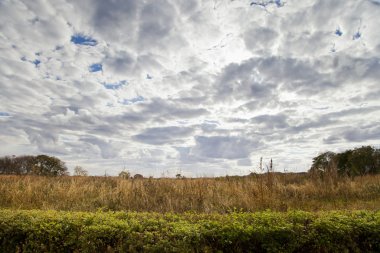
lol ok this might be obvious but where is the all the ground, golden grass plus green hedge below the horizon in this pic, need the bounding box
[0,173,380,252]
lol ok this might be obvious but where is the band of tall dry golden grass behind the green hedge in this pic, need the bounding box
[0,173,380,213]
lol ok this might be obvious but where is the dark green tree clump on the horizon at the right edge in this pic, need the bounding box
[310,146,380,176]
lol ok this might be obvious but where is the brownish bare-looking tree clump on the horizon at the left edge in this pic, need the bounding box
[0,155,67,176]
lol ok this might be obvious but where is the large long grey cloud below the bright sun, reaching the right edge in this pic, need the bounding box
[223,56,380,99]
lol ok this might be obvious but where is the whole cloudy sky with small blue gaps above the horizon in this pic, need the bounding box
[0,0,380,177]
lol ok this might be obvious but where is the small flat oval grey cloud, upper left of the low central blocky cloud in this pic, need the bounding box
[133,126,194,145]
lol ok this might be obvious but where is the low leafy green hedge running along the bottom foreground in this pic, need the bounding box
[0,210,380,252]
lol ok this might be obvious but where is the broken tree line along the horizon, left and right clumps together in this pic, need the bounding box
[0,146,380,179]
